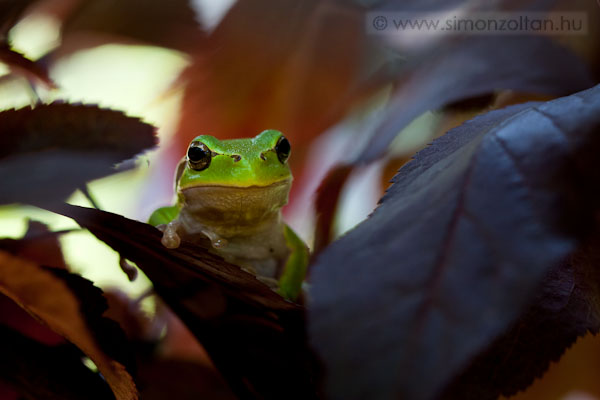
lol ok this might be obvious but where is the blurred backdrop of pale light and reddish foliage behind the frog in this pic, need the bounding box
[0,0,600,400]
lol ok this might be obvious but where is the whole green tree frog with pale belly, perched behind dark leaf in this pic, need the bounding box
[149,130,309,300]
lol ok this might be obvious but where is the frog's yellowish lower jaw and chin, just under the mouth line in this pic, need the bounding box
[180,179,291,227]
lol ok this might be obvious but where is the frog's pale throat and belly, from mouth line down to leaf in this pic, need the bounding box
[178,183,290,279]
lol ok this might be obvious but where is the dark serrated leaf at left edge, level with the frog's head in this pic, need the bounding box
[0,103,156,204]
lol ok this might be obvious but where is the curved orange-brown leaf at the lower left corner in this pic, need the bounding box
[0,251,137,400]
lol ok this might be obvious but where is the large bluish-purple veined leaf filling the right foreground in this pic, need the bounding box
[309,86,600,400]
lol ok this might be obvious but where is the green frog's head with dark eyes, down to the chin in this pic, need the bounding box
[176,130,292,228]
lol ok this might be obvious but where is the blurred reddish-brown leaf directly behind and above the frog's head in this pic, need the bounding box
[174,0,384,181]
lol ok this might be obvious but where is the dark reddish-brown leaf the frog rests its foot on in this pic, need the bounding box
[51,205,316,399]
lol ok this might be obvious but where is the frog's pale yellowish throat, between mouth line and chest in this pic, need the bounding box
[179,179,291,238]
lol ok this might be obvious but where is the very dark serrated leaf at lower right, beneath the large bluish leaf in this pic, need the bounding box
[443,236,600,400]
